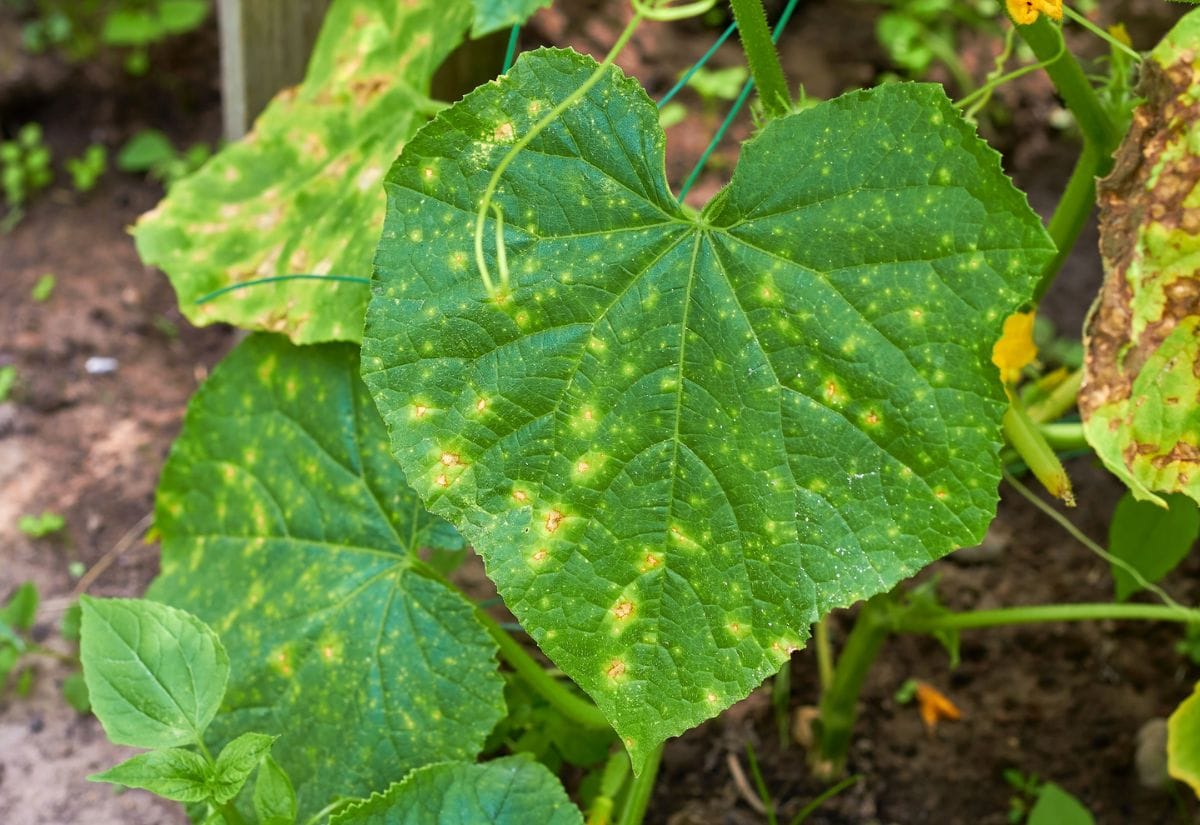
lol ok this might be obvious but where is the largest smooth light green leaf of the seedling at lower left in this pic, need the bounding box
[79,596,229,748]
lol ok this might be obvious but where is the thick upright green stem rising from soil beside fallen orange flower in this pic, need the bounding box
[816,595,888,775]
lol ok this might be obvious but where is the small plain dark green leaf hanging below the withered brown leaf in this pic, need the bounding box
[1109,492,1200,602]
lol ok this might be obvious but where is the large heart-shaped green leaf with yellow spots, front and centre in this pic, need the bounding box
[362,50,1052,770]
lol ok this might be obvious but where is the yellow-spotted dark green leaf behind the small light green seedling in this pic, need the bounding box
[150,335,504,819]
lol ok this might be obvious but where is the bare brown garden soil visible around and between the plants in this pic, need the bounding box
[0,0,1200,825]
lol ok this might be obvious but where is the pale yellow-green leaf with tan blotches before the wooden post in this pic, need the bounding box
[134,0,473,343]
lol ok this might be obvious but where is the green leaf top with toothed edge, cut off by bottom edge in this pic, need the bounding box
[330,755,583,825]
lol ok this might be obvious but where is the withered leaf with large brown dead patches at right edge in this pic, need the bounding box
[1079,11,1200,506]
